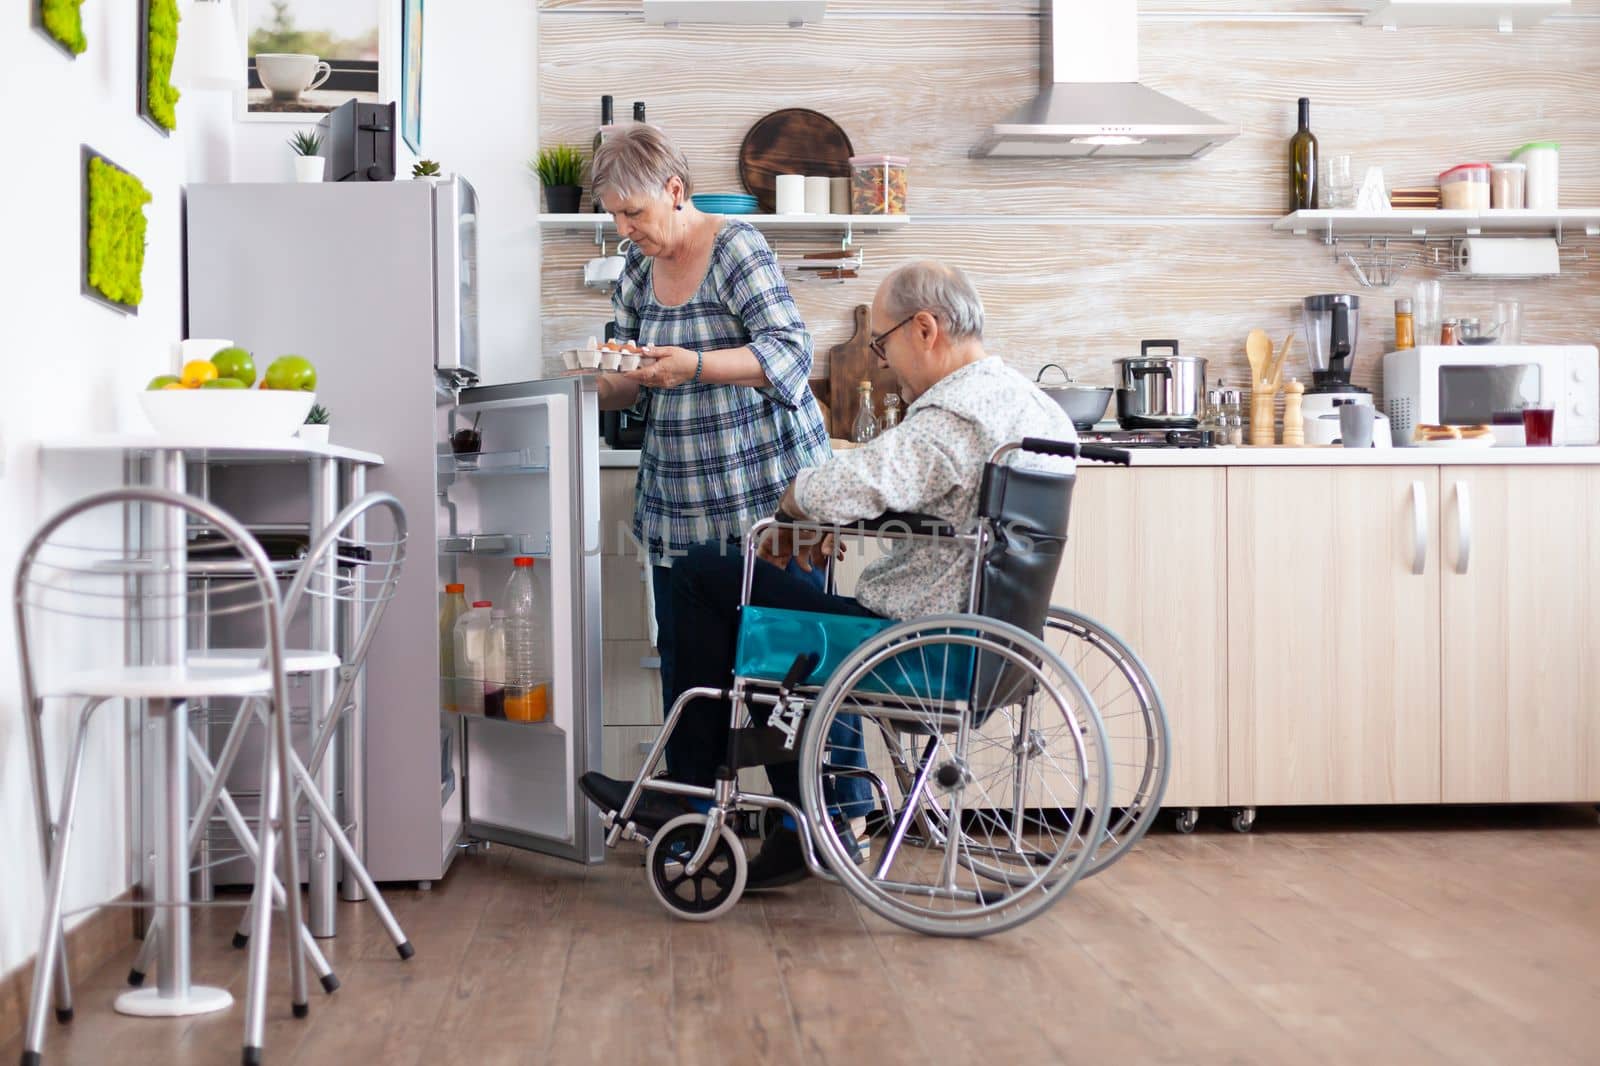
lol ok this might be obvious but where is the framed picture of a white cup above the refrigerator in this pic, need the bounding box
[238,0,389,125]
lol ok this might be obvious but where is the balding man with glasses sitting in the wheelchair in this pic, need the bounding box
[582,261,1077,892]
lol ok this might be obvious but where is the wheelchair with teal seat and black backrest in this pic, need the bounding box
[602,439,1168,936]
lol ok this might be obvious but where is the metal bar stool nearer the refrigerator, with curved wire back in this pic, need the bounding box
[128,493,414,1036]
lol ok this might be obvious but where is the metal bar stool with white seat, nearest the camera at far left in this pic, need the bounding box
[14,488,309,1066]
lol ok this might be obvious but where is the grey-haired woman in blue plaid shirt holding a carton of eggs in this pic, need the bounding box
[590,123,830,784]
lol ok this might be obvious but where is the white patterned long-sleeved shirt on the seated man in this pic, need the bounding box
[795,355,1078,619]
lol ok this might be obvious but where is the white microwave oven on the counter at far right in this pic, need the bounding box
[1384,344,1600,445]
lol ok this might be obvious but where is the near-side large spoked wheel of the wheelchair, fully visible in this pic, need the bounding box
[800,615,1110,936]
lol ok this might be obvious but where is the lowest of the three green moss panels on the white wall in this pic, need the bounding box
[83,144,150,314]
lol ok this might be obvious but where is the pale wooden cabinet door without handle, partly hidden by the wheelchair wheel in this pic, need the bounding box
[1053,466,1227,807]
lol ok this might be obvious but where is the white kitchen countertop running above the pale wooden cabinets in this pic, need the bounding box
[600,447,1600,467]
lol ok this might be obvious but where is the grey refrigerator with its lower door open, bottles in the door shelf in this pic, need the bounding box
[184,178,603,882]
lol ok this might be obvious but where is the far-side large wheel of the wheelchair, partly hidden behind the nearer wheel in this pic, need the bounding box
[1045,607,1170,877]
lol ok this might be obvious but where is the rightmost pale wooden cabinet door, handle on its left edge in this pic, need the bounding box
[1440,466,1600,804]
